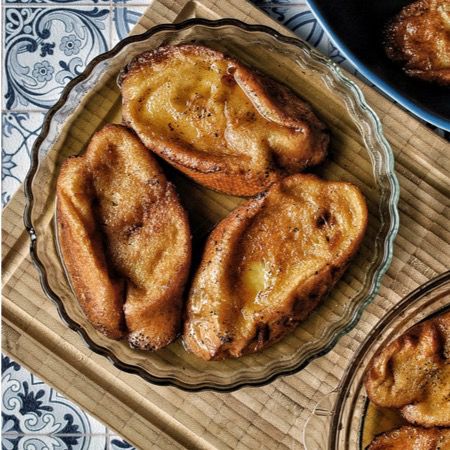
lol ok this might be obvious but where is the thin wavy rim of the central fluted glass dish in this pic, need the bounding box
[23,18,399,392]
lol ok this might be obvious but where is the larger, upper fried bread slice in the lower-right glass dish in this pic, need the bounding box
[365,312,450,426]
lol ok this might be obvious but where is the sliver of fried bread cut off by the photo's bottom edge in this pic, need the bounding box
[367,426,450,450]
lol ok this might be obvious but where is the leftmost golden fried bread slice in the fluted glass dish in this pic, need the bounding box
[57,125,191,350]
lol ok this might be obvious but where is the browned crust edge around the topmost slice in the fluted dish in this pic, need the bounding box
[118,44,330,196]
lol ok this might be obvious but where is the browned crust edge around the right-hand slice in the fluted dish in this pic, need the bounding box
[183,174,368,360]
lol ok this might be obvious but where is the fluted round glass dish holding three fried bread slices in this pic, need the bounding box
[25,19,399,391]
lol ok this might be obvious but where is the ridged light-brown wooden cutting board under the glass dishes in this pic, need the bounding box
[2,0,450,450]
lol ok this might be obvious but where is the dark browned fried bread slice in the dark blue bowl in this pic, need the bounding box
[385,0,450,86]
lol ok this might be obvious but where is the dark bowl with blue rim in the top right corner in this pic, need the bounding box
[307,0,450,131]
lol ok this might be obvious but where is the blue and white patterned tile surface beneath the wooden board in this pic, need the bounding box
[1,0,446,450]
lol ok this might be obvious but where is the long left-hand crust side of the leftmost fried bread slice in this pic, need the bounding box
[57,159,126,339]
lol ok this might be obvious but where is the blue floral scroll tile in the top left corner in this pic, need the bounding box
[3,7,110,110]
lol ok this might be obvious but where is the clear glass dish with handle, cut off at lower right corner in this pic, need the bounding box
[303,271,450,450]
